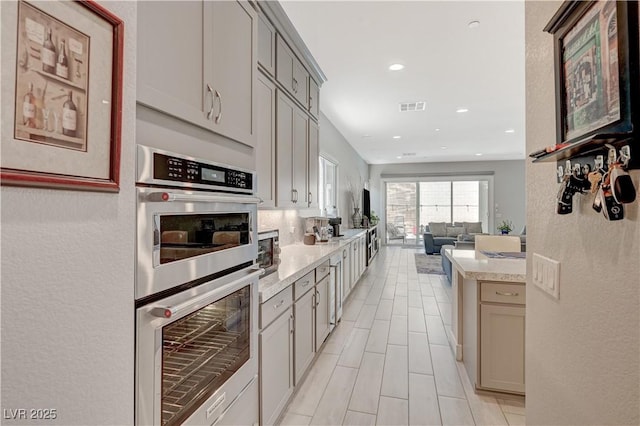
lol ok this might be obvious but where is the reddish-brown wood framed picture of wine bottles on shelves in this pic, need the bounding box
[0,0,124,192]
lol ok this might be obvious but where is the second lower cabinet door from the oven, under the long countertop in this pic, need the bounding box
[293,290,315,385]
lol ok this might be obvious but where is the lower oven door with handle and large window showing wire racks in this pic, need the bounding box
[136,268,263,426]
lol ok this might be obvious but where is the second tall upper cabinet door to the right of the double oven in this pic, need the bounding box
[276,89,295,207]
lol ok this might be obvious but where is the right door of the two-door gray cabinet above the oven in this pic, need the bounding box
[205,1,258,146]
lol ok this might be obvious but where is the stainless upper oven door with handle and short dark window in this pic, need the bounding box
[135,188,259,299]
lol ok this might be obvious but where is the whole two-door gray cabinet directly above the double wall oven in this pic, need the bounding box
[137,1,258,146]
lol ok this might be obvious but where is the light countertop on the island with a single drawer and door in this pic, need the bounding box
[445,249,527,282]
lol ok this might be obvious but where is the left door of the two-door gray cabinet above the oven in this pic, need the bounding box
[136,1,209,127]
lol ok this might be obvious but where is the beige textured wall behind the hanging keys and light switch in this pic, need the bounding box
[525,1,640,425]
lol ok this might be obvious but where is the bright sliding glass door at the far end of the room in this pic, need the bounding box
[386,177,492,245]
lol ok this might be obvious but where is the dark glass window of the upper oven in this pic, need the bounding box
[159,212,250,264]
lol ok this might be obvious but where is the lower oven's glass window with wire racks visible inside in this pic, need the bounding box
[162,286,251,425]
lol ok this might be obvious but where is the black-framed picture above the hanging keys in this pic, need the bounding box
[544,0,639,146]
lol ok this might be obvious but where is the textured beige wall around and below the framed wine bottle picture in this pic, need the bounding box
[0,2,137,425]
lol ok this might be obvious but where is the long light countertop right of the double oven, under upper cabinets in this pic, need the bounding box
[258,229,367,303]
